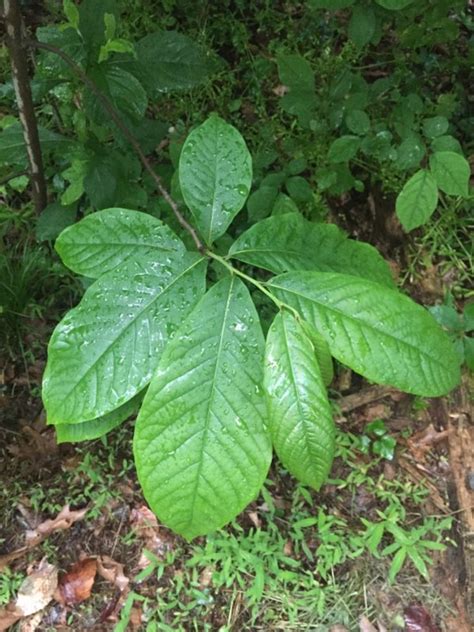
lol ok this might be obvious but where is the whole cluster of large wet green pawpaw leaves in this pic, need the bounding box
[43,116,460,539]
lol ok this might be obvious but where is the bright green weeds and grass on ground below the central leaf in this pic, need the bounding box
[111,434,452,631]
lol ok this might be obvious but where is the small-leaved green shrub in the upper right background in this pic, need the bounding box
[272,0,470,232]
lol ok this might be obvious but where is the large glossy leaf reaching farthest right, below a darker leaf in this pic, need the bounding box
[269,272,460,397]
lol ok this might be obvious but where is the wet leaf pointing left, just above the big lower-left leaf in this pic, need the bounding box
[55,208,185,278]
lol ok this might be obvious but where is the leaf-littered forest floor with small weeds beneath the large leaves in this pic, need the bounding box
[0,204,474,632]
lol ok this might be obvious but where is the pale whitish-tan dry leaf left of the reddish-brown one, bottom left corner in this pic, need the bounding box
[15,559,58,617]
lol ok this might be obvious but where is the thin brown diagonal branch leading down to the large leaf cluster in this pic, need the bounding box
[26,40,205,253]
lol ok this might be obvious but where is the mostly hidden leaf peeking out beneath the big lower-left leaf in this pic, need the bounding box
[56,393,143,443]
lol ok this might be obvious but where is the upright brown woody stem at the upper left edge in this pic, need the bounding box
[3,0,47,214]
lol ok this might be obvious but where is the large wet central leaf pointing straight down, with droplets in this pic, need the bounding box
[134,277,271,539]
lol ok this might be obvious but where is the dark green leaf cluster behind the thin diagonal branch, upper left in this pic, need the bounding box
[0,0,216,227]
